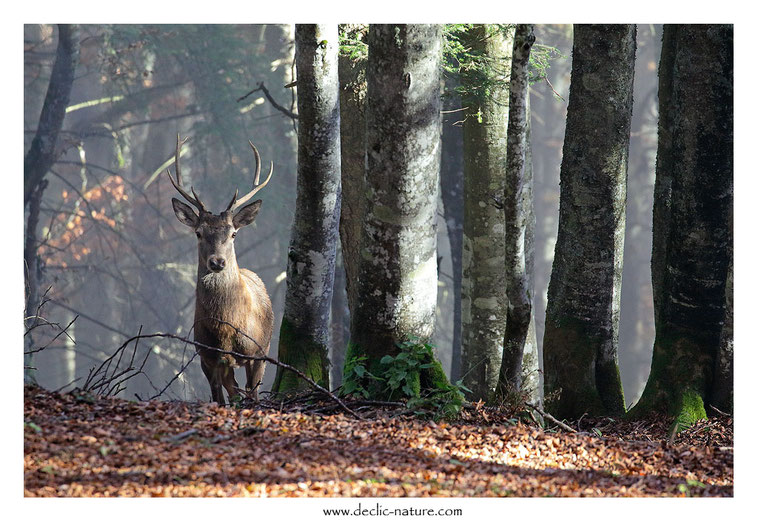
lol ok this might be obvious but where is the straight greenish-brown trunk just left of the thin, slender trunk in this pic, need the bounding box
[461,24,513,400]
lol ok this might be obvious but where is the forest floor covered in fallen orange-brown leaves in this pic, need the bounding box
[24,386,734,497]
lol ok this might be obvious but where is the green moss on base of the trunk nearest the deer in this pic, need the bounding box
[271,318,329,393]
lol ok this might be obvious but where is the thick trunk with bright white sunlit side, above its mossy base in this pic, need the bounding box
[346,24,444,394]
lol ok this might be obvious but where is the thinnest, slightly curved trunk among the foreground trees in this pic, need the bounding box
[498,24,534,398]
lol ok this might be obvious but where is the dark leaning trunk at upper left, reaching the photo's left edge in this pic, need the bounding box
[24,24,79,206]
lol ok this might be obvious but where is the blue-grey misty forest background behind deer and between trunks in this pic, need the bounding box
[24,25,661,404]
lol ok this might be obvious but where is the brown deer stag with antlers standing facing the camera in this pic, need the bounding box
[167,136,274,406]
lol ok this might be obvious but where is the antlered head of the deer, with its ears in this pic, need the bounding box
[166,135,274,273]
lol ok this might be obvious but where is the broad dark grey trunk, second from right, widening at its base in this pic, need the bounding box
[543,25,636,418]
